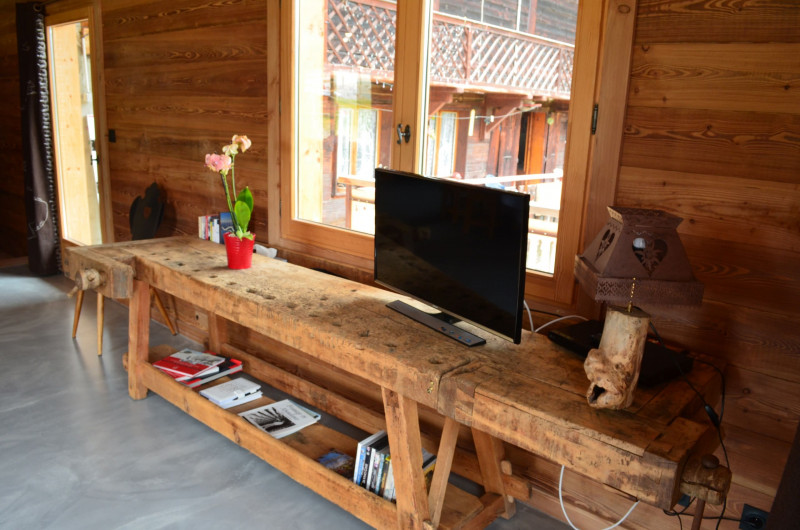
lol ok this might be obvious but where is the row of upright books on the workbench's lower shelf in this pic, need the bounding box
[353,431,436,501]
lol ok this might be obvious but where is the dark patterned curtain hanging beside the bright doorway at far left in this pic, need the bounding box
[17,2,61,275]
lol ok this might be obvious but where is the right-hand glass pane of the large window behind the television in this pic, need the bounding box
[424,0,578,273]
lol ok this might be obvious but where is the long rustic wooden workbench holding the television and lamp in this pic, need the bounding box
[65,238,730,528]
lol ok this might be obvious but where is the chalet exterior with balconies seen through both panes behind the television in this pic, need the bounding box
[294,0,577,273]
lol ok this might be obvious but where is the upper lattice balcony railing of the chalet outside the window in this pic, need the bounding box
[327,0,574,99]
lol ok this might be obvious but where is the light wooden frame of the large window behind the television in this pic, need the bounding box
[267,0,636,307]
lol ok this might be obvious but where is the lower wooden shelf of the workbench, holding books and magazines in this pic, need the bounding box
[134,346,503,529]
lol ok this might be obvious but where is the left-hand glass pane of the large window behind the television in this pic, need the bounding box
[293,0,396,233]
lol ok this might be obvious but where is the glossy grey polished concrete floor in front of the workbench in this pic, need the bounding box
[0,265,568,530]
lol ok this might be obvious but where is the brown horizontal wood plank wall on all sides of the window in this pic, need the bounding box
[0,0,800,530]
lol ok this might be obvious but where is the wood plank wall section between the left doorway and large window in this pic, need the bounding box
[103,0,267,239]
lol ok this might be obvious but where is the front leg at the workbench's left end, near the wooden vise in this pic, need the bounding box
[128,280,150,399]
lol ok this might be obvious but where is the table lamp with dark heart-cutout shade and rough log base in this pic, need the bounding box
[575,206,703,409]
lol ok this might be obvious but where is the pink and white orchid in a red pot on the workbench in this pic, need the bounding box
[206,134,255,269]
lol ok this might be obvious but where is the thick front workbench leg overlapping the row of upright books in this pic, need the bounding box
[381,388,432,530]
